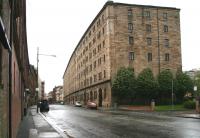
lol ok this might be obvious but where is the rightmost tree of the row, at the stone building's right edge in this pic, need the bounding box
[175,71,193,101]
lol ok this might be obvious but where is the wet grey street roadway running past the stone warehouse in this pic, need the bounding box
[43,105,200,138]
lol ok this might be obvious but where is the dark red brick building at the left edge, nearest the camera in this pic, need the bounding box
[0,0,29,138]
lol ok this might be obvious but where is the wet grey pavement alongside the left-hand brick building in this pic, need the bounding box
[17,106,68,138]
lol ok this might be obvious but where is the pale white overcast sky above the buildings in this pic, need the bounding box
[27,0,200,93]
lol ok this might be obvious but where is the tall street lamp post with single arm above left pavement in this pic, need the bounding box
[36,47,56,113]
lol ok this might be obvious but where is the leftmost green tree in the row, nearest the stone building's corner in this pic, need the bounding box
[112,67,136,103]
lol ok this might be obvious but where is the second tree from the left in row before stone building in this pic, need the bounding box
[137,68,158,102]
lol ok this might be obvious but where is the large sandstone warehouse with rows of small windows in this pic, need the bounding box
[63,1,182,107]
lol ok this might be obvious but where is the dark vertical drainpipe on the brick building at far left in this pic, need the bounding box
[9,0,14,138]
